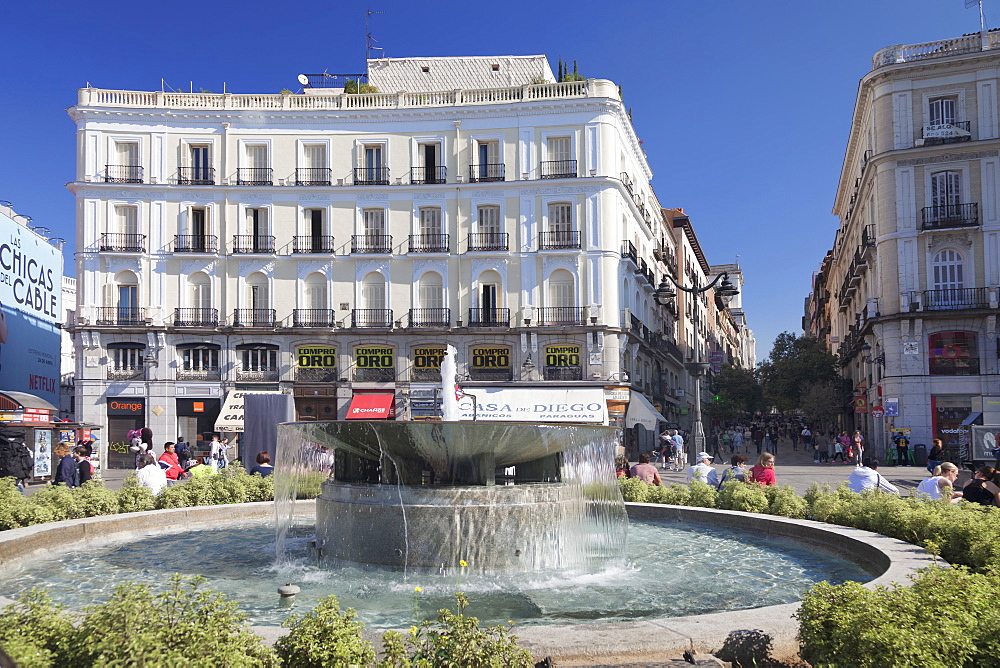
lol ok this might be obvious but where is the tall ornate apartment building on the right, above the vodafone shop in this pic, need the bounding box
[804,32,1000,461]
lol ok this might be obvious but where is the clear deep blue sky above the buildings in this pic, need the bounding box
[0,0,1000,358]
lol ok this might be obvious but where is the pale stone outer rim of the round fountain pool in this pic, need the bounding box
[0,500,943,665]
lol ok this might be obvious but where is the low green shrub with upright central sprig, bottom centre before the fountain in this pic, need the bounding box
[382,592,534,668]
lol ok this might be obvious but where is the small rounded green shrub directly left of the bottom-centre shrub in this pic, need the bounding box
[274,596,375,668]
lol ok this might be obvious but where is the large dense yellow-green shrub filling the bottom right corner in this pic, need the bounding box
[796,568,1000,668]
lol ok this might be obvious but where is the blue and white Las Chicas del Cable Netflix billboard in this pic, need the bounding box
[0,212,63,406]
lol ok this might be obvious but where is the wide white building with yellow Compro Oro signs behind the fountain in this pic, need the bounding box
[69,56,744,466]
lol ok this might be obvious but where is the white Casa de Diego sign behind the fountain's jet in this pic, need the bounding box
[458,386,608,424]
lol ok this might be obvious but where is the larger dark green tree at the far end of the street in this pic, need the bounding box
[758,332,849,419]
